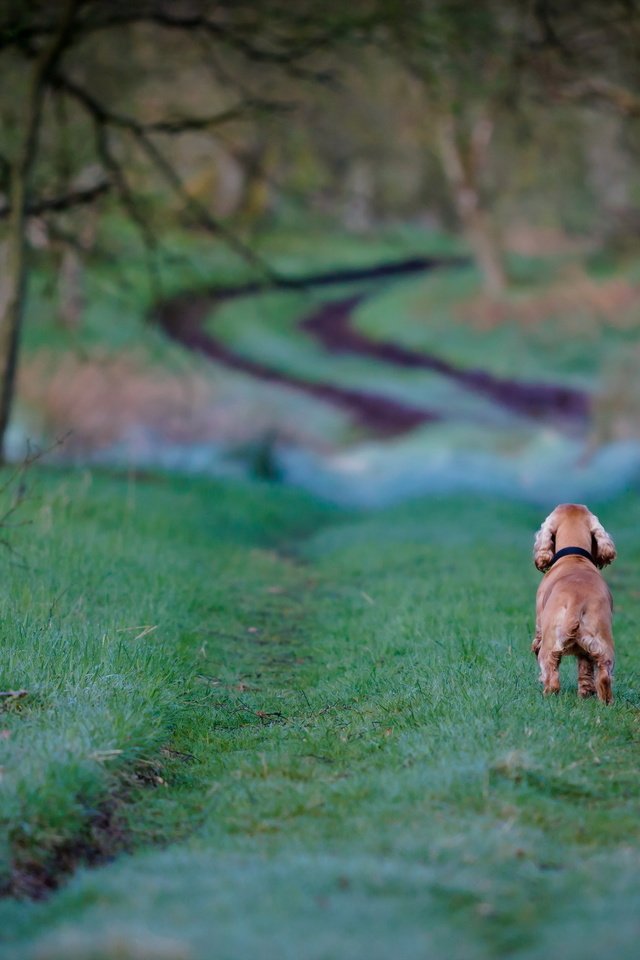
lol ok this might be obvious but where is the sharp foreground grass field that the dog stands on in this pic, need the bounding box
[0,471,640,960]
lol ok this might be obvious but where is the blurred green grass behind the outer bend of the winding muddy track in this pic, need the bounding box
[24,214,460,362]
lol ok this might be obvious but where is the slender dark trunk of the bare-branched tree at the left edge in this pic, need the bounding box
[0,0,79,462]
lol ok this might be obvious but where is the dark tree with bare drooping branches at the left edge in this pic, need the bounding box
[0,0,350,456]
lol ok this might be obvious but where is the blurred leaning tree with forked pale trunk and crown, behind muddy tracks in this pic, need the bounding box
[362,0,514,296]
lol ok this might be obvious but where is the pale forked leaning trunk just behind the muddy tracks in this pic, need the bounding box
[439,114,507,297]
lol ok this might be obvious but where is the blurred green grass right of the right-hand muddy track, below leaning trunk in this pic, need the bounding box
[356,258,638,388]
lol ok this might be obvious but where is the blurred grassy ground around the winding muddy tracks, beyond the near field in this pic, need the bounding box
[16,219,640,505]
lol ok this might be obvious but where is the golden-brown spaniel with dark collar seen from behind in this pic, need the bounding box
[531,503,616,703]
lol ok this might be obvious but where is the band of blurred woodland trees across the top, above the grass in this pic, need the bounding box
[0,0,640,464]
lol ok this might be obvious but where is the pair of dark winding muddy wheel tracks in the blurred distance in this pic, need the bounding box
[153,257,589,435]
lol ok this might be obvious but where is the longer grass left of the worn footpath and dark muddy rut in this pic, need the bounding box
[0,473,330,883]
